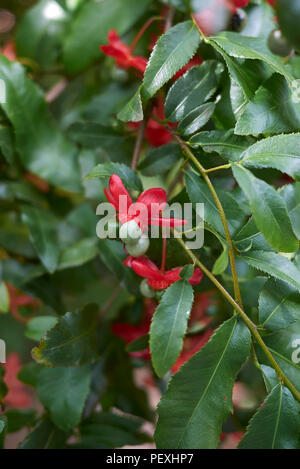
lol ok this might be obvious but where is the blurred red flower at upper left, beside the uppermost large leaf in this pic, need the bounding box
[100,29,147,73]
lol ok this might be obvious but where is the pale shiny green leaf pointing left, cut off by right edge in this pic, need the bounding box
[241,133,300,180]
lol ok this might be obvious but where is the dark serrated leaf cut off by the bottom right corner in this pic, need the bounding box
[238,384,300,449]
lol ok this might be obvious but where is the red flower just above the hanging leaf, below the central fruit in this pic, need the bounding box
[124,256,203,290]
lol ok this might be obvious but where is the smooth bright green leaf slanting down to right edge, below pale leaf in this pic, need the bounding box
[232,165,299,252]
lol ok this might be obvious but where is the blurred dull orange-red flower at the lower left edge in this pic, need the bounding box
[3,353,31,409]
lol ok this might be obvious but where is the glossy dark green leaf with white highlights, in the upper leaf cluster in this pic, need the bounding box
[165,60,223,122]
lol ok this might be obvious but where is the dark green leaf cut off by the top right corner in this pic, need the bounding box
[276,0,300,50]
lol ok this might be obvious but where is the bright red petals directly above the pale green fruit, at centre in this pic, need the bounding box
[104,174,186,230]
